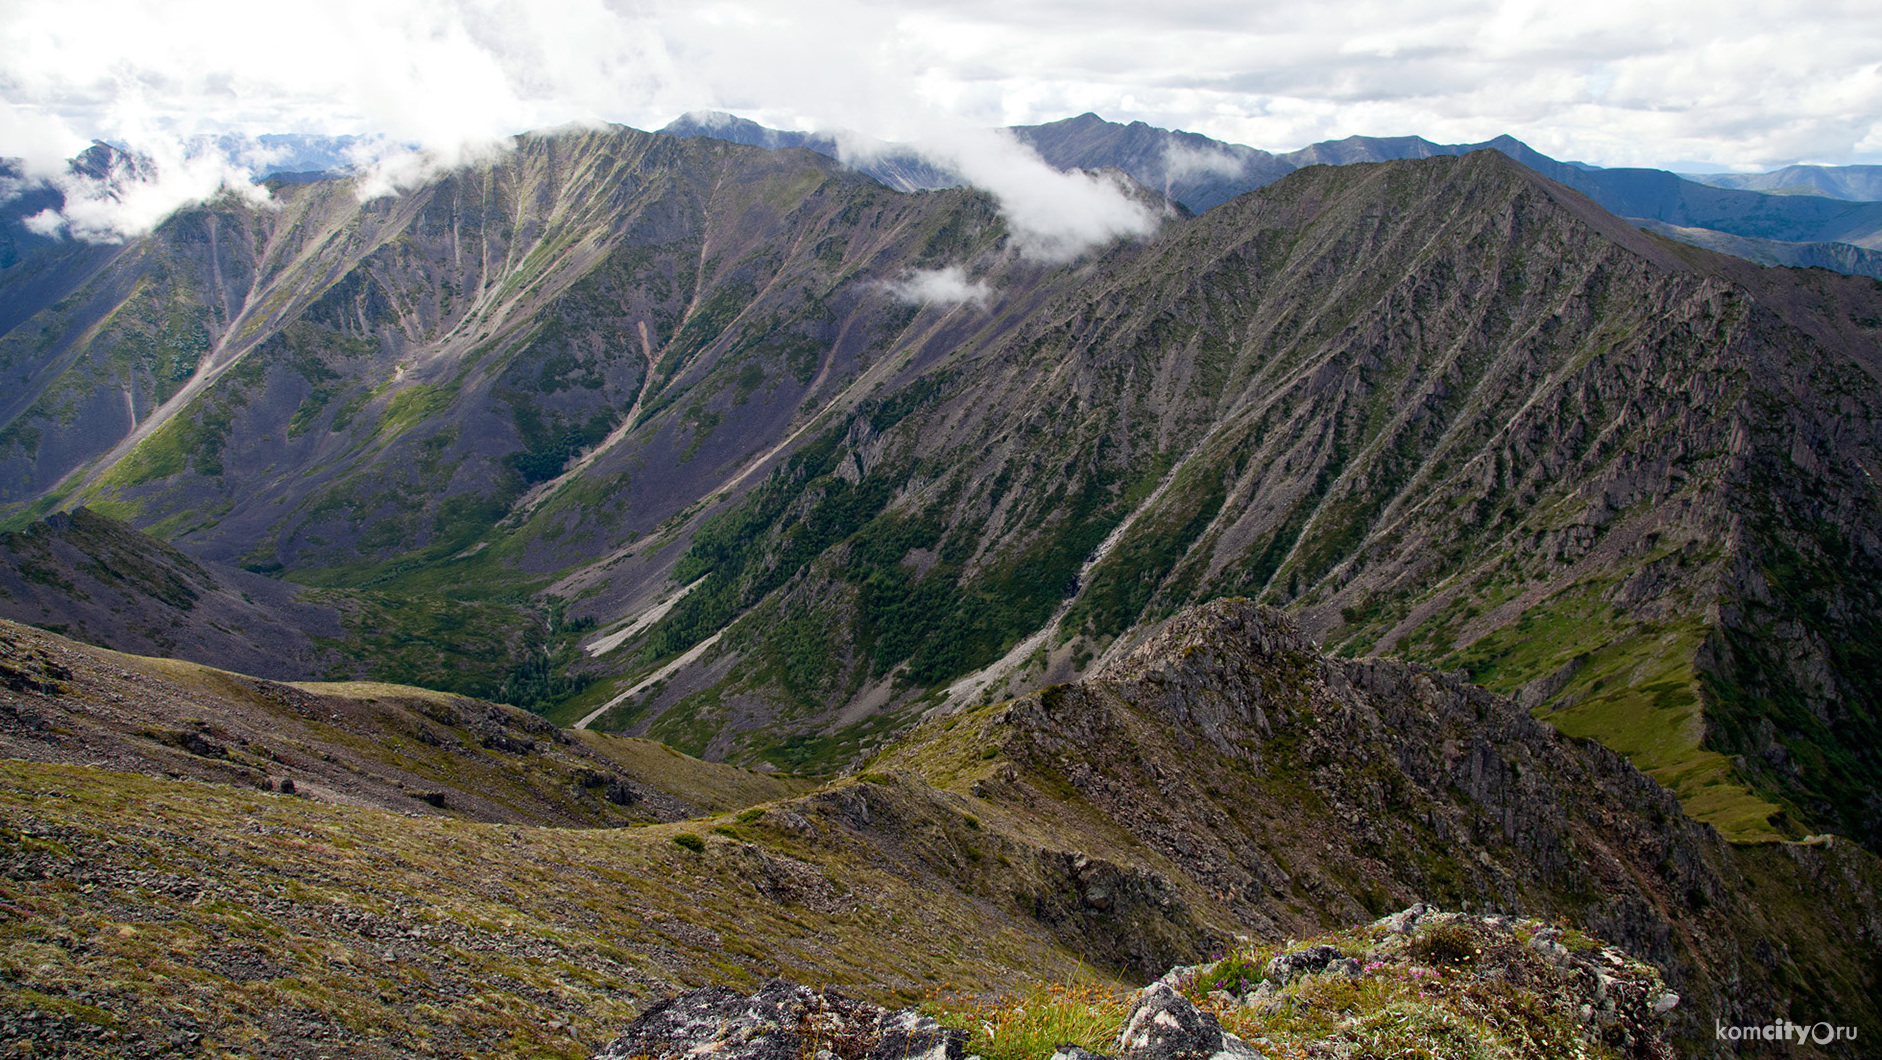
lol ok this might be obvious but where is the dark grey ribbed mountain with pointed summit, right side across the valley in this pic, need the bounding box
[583,153,1882,836]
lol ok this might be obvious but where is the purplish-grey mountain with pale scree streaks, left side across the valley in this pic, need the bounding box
[8,130,1016,567]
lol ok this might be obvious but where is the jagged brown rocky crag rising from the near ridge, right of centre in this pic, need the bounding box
[886,601,1882,1047]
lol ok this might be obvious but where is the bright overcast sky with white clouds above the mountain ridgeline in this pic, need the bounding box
[0,0,1882,239]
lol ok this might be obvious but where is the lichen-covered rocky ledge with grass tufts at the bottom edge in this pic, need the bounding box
[595,906,1679,1060]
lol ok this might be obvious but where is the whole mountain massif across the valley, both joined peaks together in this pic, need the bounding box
[0,130,1882,843]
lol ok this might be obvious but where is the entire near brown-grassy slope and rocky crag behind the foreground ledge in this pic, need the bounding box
[0,601,1882,1056]
